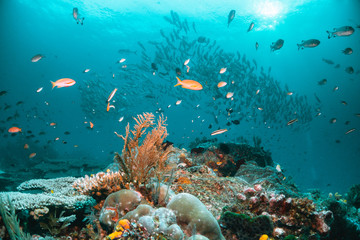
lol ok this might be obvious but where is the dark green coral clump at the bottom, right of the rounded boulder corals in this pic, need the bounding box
[220,211,274,240]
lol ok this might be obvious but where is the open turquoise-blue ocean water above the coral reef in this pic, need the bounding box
[0,0,360,195]
